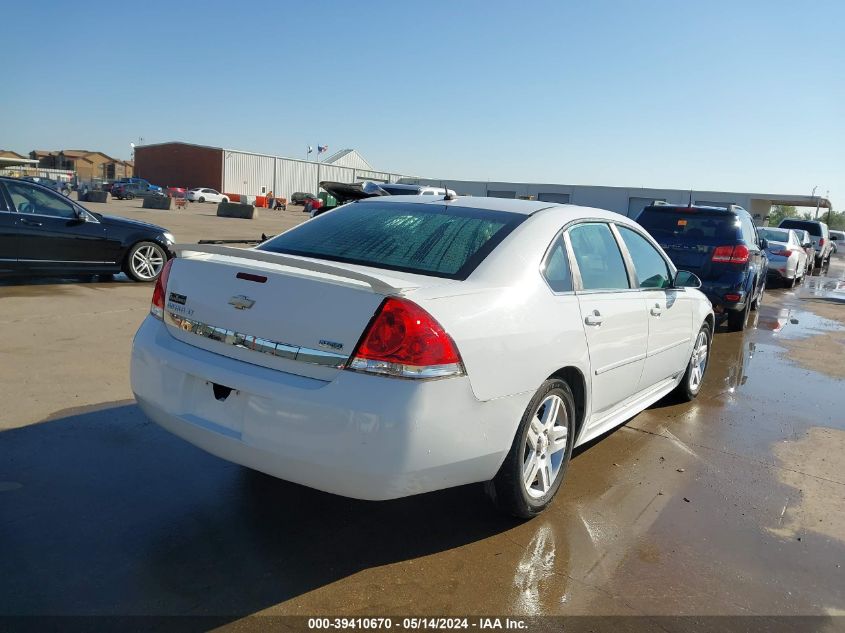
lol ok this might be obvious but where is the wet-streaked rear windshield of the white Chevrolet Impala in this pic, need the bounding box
[258,202,527,279]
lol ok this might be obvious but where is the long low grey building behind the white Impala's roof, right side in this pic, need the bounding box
[400,178,831,224]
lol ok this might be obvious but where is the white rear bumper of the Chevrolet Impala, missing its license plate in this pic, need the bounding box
[131,317,532,500]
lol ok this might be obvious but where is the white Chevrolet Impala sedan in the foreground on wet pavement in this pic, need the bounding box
[131,196,714,517]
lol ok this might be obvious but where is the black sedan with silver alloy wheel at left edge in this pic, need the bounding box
[0,177,173,281]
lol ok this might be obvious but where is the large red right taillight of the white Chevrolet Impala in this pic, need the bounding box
[346,297,464,378]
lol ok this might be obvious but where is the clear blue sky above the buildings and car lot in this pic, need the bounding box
[0,0,845,208]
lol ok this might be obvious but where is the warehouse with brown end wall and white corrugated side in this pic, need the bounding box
[135,142,401,198]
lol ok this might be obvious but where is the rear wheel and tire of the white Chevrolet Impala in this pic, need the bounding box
[492,379,576,519]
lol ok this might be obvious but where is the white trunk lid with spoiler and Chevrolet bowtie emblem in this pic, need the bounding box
[164,246,454,381]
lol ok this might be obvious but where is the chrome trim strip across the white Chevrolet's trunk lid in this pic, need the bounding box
[164,310,349,369]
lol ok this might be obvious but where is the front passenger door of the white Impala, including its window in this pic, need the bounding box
[616,225,693,391]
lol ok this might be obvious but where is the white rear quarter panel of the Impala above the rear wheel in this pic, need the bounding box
[410,207,592,402]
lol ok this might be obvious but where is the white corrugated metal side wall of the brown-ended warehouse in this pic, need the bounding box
[223,150,402,198]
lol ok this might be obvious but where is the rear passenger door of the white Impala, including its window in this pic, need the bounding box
[567,222,648,424]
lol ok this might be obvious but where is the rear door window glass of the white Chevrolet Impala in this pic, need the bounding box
[569,224,630,290]
